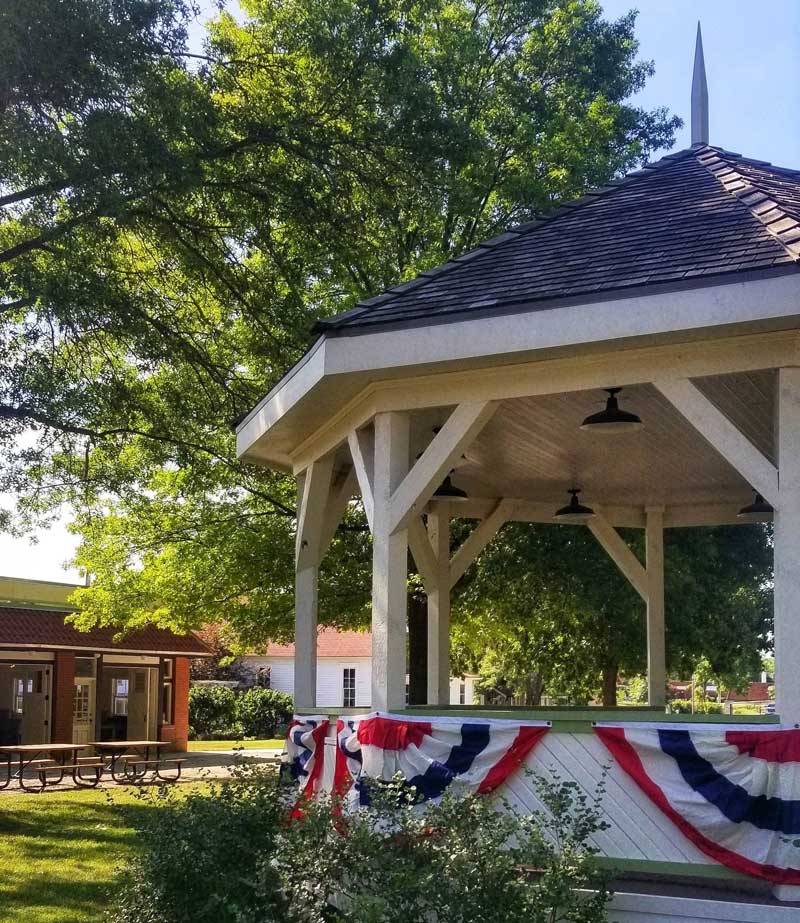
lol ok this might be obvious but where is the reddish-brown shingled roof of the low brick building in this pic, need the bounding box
[0,606,211,657]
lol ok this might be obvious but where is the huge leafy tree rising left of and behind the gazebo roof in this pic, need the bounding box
[6,0,764,700]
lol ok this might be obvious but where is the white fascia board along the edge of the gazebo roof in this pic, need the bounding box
[236,273,800,462]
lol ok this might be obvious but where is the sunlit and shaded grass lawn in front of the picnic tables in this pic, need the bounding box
[0,788,200,923]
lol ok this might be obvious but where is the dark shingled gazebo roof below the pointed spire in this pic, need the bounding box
[319,144,800,335]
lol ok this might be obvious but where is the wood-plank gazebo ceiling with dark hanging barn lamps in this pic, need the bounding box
[404,370,776,509]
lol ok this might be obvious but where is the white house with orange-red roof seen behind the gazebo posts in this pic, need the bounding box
[240,628,478,710]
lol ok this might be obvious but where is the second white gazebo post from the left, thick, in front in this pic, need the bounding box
[372,412,409,711]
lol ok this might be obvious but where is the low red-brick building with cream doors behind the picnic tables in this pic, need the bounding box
[0,577,209,750]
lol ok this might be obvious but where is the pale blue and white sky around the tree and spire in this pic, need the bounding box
[0,0,800,582]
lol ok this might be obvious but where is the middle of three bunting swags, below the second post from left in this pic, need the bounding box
[334,712,549,804]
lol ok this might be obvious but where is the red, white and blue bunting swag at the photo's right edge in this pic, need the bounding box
[595,725,800,885]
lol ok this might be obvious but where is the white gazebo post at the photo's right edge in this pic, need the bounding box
[774,368,800,724]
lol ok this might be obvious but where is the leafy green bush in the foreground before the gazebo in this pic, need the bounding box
[109,768,609,923]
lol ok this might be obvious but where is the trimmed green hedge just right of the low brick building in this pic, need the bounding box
[189,686,293,740]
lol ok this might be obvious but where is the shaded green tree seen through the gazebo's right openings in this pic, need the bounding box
[455,524,772,705]
